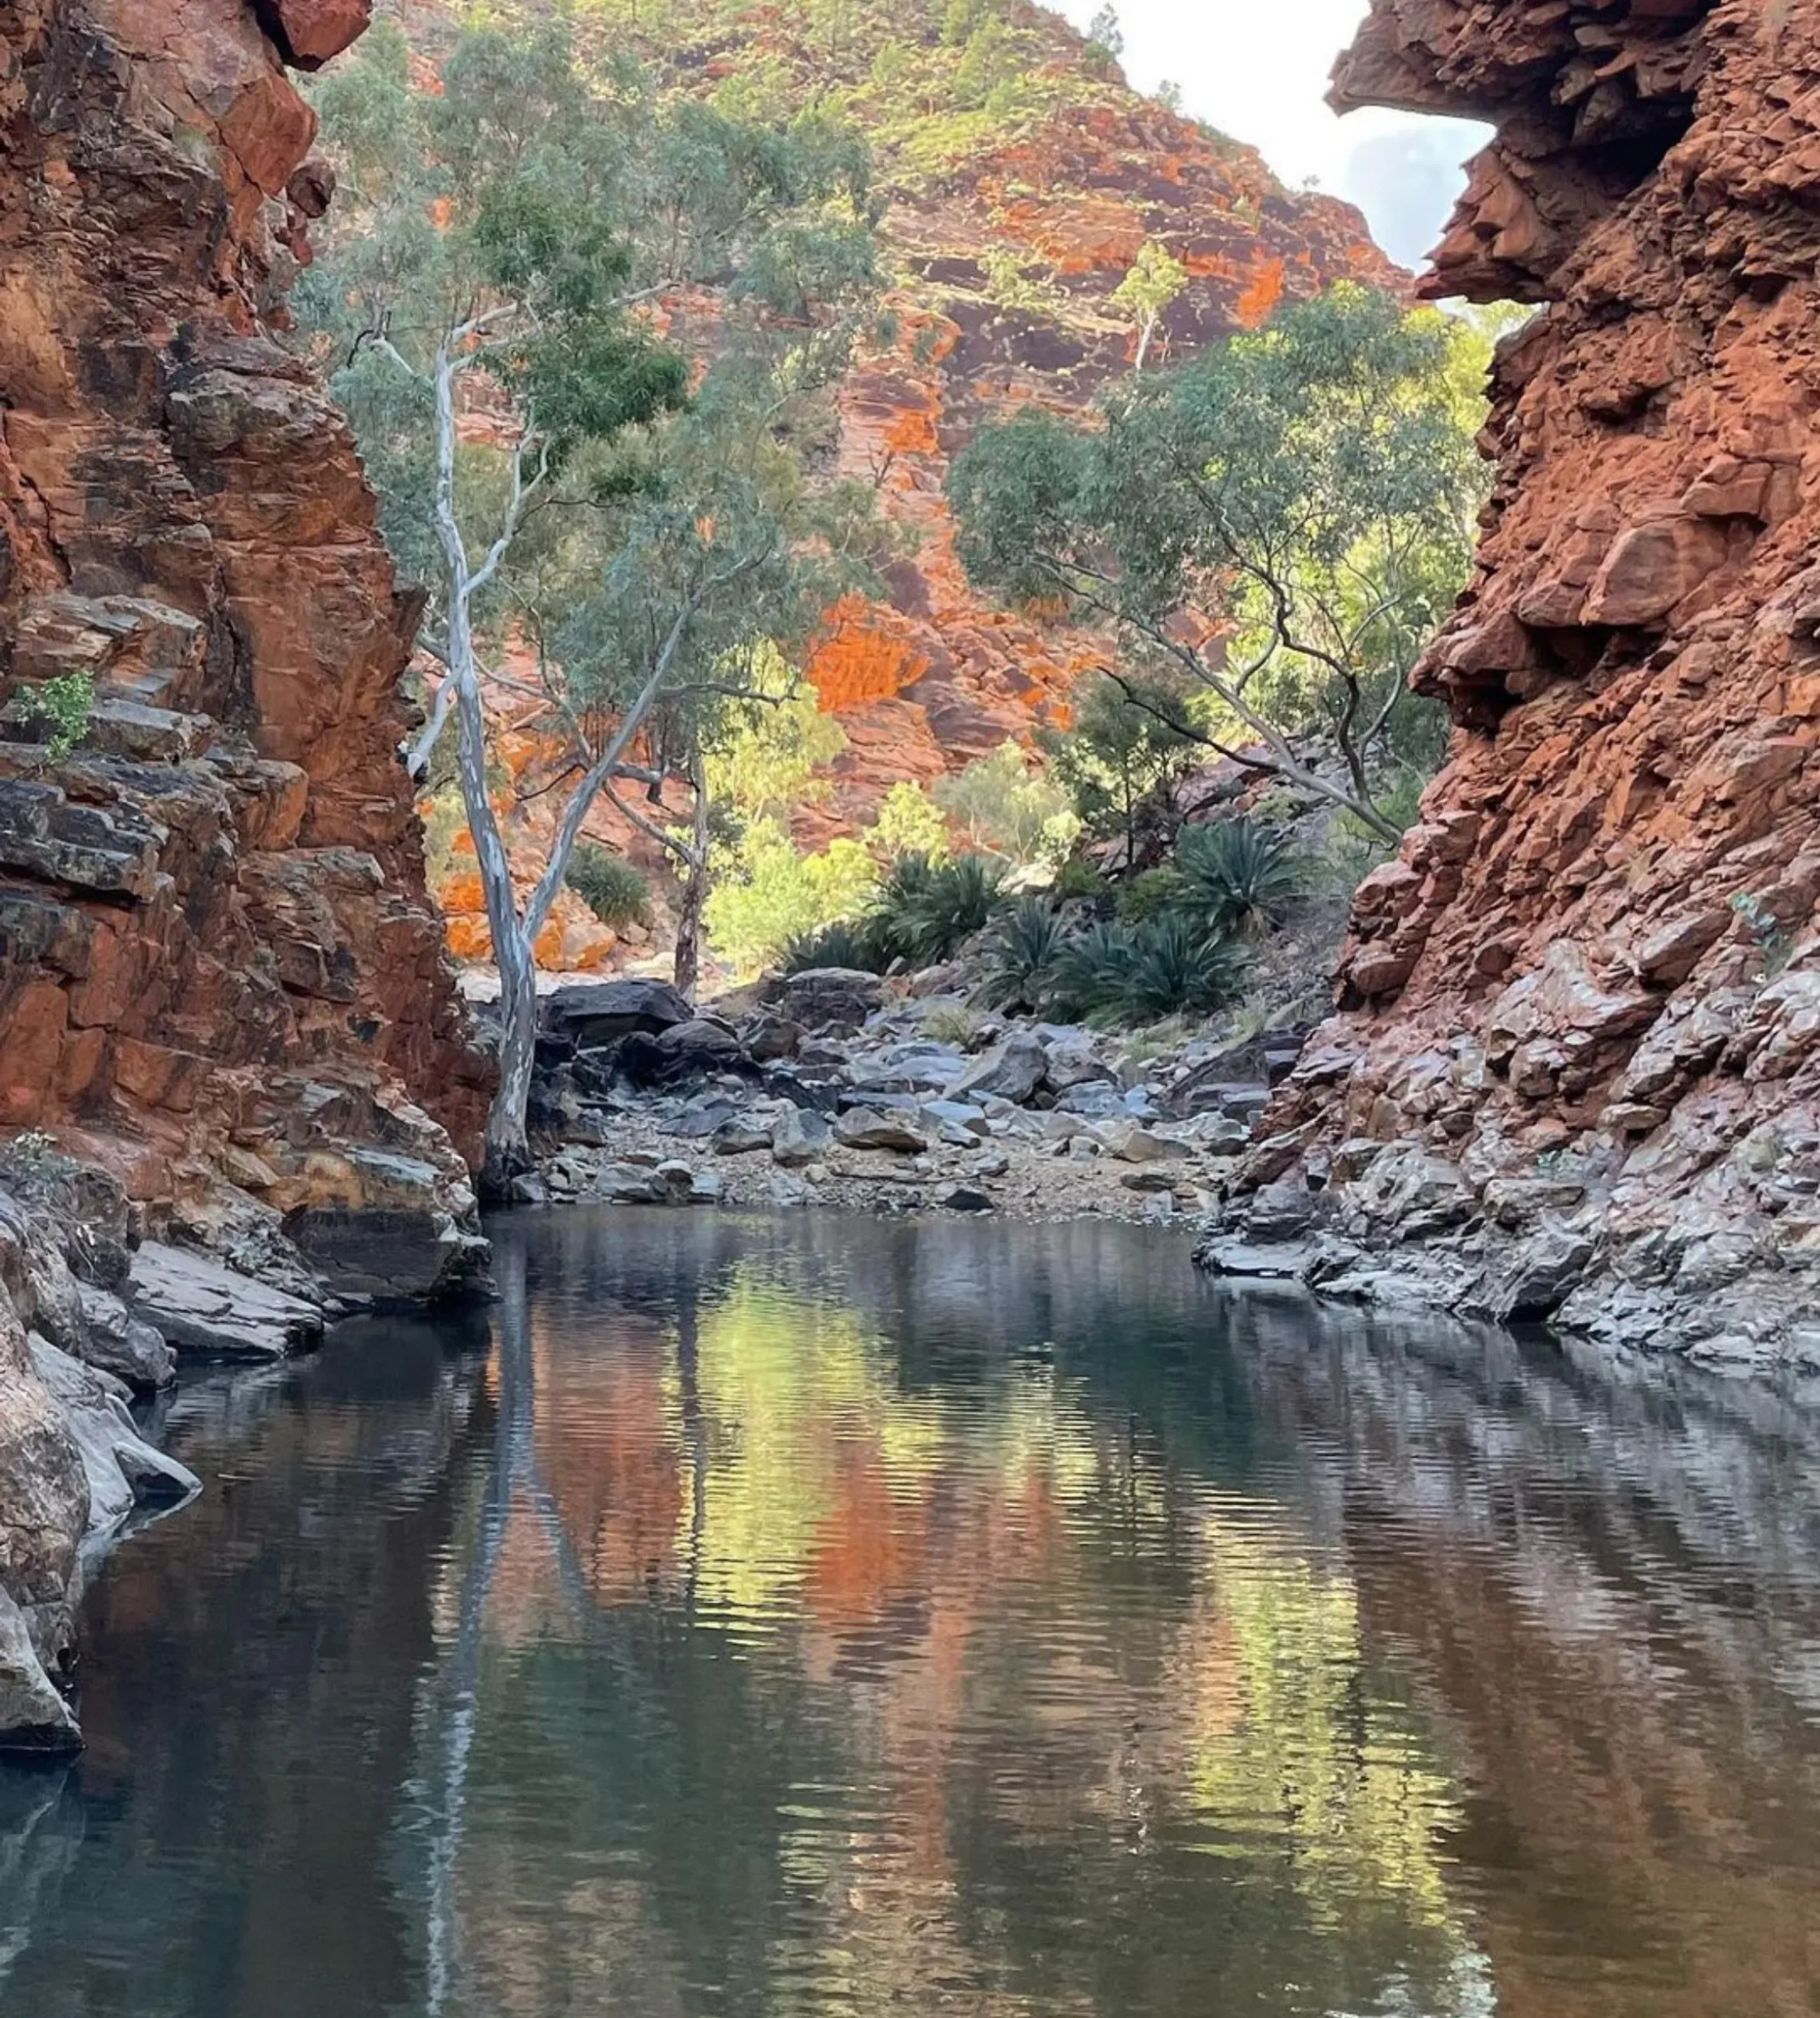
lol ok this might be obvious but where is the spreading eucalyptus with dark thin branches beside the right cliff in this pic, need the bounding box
[951,285,1485,842]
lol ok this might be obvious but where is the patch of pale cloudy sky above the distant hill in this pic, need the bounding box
[1049,0,1489,266]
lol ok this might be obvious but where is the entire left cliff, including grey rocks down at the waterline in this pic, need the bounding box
[0,0,486,1748]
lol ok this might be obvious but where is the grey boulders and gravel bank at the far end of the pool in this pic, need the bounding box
[498,969,1300,1219]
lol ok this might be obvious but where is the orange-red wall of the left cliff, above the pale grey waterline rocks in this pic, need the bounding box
[0,0,486,1251]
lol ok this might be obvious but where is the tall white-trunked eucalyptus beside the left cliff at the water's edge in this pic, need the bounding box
[300,22,876,1185]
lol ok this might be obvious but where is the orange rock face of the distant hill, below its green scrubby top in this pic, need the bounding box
[810,95,1402,819]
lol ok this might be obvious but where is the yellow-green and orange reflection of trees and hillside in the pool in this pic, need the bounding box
[405,1211,1479,2014]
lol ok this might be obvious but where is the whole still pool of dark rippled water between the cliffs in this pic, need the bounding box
[0,1211,1820,2018]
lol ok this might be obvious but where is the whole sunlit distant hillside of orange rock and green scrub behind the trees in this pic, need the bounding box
[348,0,1401,965]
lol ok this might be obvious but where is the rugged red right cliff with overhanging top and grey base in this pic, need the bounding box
[1208,0,1820,1366]
